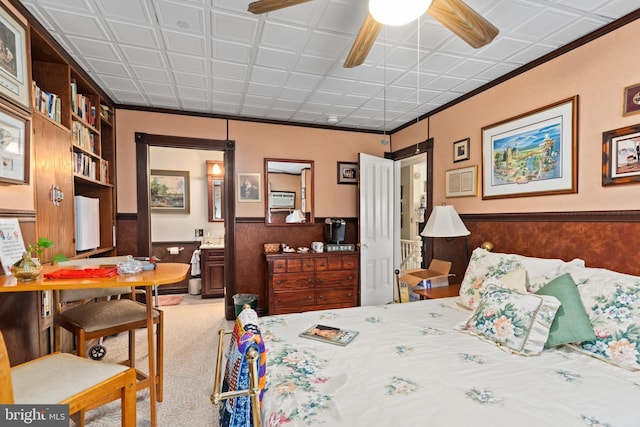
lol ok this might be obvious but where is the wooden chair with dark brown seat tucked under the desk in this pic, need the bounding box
[54,257,164,402]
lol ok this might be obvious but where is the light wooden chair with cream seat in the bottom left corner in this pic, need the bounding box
[0,332,136,427]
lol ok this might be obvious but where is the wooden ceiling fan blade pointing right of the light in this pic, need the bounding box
[427,0,500,49]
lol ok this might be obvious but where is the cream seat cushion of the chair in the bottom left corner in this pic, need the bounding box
[11,353,129,404]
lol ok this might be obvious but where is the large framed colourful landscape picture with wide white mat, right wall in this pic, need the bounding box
[482,95,578,199]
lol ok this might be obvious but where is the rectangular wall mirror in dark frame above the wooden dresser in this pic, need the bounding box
[264,159,314,226]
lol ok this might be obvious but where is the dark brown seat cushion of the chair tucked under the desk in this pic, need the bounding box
[58,298,159,332]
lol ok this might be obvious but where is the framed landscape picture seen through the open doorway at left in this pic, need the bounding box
[149,169,189,214]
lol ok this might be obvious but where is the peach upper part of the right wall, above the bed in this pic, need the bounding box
[392,21,640,213]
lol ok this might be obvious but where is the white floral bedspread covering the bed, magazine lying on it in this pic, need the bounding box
[260,299,640,427]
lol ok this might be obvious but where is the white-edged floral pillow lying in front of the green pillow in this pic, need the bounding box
[456,285,560,355]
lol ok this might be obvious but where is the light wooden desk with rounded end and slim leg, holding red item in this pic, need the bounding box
[0,263,190,427]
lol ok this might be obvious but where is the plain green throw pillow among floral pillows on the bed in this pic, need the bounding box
[536,273,596,348]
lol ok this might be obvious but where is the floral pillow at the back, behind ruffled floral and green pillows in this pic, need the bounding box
[458,248,584,309]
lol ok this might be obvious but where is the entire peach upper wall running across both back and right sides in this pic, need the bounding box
[112,21,640,217]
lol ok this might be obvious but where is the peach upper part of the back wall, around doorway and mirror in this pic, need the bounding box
[116,110,388,217]
